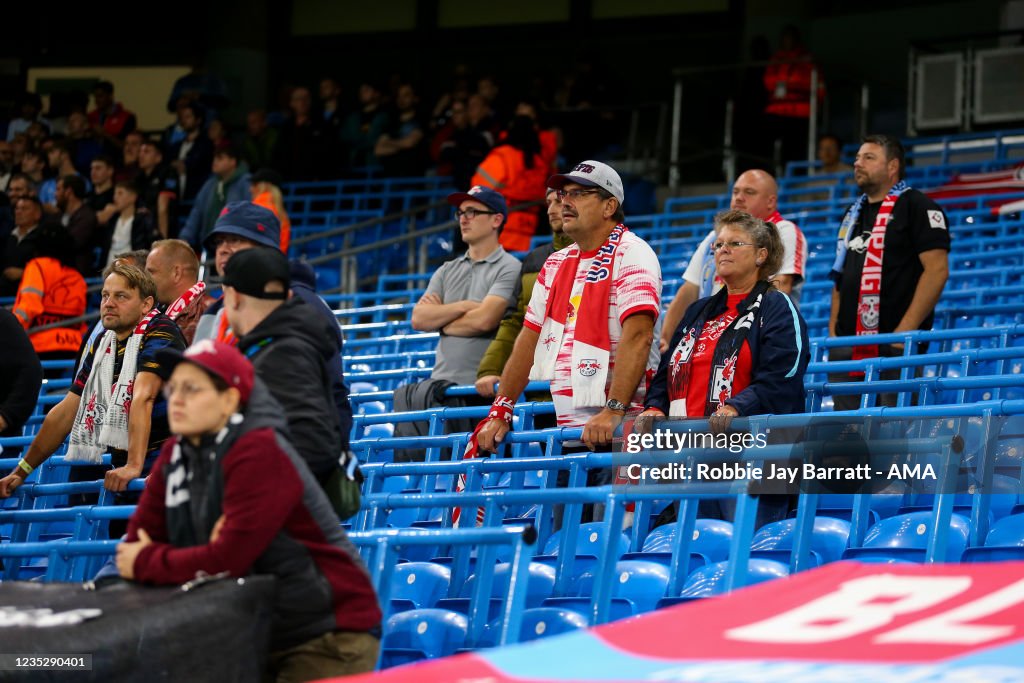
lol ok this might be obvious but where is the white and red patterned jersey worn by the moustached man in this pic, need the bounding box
[523,232,662,427]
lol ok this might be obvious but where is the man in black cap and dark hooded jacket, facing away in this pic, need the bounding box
[223,249,342,485]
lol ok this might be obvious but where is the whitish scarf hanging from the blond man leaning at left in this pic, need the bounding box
[66,308,160,463]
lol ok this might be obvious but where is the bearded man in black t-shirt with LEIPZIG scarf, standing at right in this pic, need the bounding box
[828,135,950,410]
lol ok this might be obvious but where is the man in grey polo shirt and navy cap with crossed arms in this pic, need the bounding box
[413,186,521,384]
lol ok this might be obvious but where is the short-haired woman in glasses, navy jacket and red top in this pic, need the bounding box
[642,211,810,426]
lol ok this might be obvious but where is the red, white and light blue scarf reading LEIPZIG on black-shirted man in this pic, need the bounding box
[829,180,910,360]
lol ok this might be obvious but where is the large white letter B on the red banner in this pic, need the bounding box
[725,574,971,643]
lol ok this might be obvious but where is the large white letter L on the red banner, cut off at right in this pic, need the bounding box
[876,581,1024,645]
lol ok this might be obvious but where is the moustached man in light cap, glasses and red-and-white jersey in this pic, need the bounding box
[476,161,662,458]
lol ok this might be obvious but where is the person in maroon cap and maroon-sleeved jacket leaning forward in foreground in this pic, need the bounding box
[116,341,382,681]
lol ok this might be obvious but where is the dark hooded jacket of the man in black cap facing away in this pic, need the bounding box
[239,298,342,481]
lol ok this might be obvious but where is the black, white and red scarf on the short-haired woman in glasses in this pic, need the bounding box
[669,280,771,417]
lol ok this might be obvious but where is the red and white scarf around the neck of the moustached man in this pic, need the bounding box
[529,223,629,408]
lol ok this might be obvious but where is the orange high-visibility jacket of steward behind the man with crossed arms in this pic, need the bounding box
[471,144,551,251]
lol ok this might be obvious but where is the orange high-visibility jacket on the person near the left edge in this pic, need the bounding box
[13,256,86,353]
